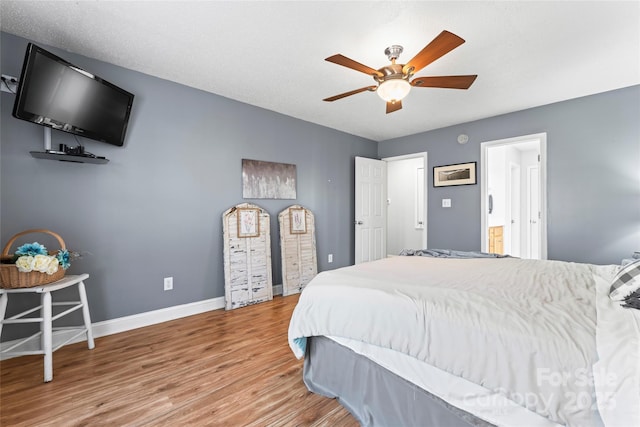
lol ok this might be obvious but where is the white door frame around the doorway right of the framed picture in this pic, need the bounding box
[480,132,547,259]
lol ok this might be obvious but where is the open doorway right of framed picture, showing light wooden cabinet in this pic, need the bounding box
[481,133,547,259]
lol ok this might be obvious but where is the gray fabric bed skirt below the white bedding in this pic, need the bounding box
[303,337,492,427]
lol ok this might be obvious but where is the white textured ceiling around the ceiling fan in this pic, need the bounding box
[0,0,640,141]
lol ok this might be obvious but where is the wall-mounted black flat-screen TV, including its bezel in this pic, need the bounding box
[13,43,133,146]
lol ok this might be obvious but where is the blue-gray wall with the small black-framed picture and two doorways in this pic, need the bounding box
[378,86,640,264]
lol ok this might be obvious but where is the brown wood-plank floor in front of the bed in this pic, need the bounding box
[0,296,358,427]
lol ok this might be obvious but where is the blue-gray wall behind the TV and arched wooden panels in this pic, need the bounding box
[0,33,377,341]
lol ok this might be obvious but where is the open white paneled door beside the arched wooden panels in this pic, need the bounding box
[354,157,387,264]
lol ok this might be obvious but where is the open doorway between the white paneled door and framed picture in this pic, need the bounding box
[382,152,427,256]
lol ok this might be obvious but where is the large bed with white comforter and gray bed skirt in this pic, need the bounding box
[289,256,640,426]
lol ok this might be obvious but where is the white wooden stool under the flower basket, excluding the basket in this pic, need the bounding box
[0,274,95,382]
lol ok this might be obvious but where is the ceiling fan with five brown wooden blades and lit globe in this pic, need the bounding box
[323,31,478,114]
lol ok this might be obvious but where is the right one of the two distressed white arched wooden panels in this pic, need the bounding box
[278,205,318,296]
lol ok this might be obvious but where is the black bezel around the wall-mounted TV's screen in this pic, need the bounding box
[13,43,134,147]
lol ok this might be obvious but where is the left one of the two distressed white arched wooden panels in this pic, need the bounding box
[222,203,273,310]
